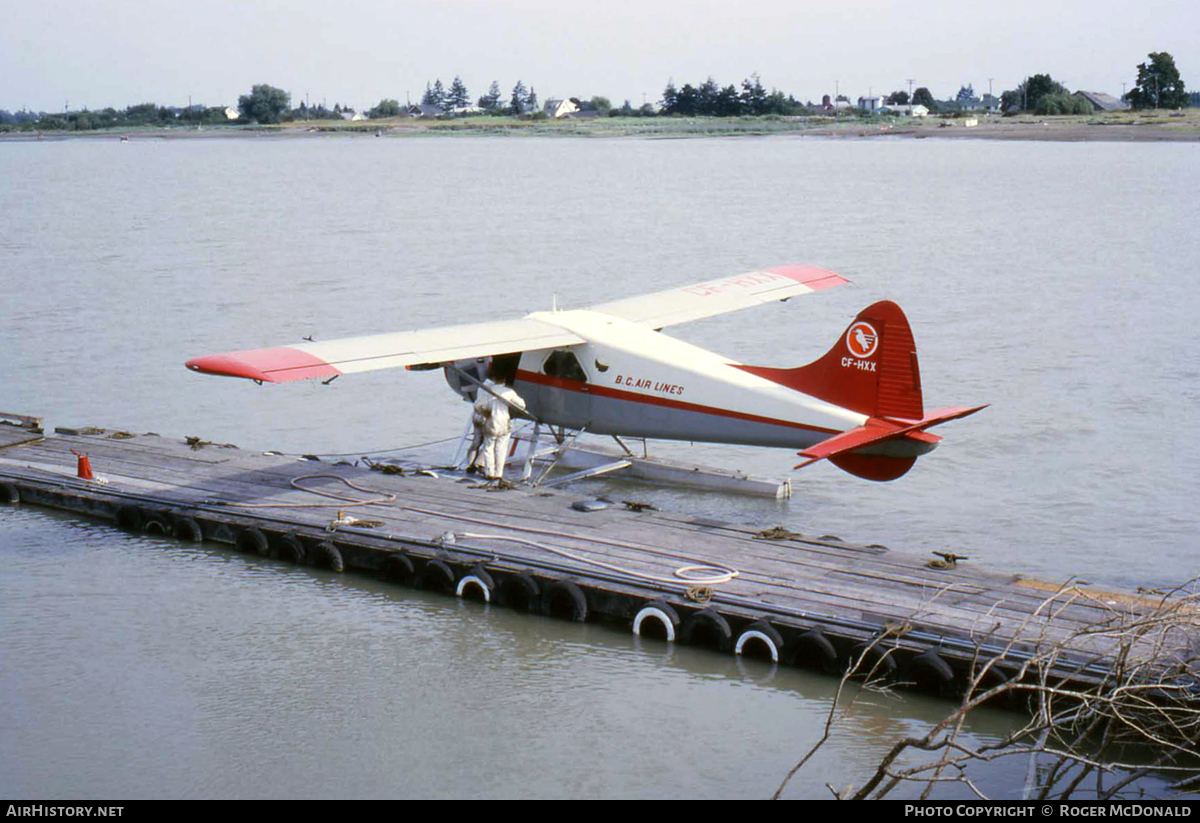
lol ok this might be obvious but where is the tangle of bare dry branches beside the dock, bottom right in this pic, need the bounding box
[774,581,1200,800]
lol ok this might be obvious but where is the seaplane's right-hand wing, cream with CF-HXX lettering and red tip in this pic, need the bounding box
[592,265,850,329]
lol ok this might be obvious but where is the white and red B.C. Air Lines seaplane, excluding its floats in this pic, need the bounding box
[186,265,985,481]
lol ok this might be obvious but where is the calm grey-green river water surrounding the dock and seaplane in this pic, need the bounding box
[0,138,1200,797]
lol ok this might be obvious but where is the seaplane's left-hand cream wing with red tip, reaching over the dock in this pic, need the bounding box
[186,318,583,383]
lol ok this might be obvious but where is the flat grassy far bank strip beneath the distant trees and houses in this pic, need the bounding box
[0,109,1200,143]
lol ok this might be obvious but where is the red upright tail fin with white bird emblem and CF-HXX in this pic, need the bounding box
[740,300,925,421]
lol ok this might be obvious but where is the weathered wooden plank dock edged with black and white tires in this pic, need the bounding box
[0,415,1194,695]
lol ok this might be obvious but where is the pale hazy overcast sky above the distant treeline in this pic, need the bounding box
[0,0,1200,110]
